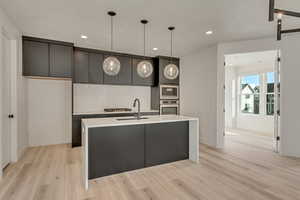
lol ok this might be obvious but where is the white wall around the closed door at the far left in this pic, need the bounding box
[0,8,28,161]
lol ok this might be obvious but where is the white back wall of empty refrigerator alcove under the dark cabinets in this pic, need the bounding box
[27,79,72,146]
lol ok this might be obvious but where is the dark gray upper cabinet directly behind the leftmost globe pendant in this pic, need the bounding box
[103,55,132,85]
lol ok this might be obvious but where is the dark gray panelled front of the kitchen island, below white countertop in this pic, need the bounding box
[88,121,189,179]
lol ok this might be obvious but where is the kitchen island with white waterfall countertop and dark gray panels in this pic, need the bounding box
[82,115,199,189]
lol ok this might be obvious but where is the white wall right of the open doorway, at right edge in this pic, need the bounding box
[281,34,300,157]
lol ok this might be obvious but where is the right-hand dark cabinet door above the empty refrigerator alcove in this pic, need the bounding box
[50,44,73,78]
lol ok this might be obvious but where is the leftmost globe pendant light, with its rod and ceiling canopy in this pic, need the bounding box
[103,11,121,76]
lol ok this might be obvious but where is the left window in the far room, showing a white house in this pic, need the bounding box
[240,74,260,114]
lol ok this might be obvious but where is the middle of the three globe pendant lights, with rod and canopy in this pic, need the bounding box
[136,19,153,78]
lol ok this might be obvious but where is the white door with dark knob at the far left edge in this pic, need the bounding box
[1,33,11,168]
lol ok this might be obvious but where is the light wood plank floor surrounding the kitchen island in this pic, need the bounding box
[0,138,300,200]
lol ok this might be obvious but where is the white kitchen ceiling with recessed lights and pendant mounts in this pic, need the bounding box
[0,0,300,56]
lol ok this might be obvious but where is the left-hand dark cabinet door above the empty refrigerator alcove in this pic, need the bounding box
[23,40,49,77]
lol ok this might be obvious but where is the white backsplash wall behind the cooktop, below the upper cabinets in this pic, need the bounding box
[74,84,151,113]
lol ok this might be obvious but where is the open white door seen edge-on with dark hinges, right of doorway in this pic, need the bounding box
[274,51,281,153]
